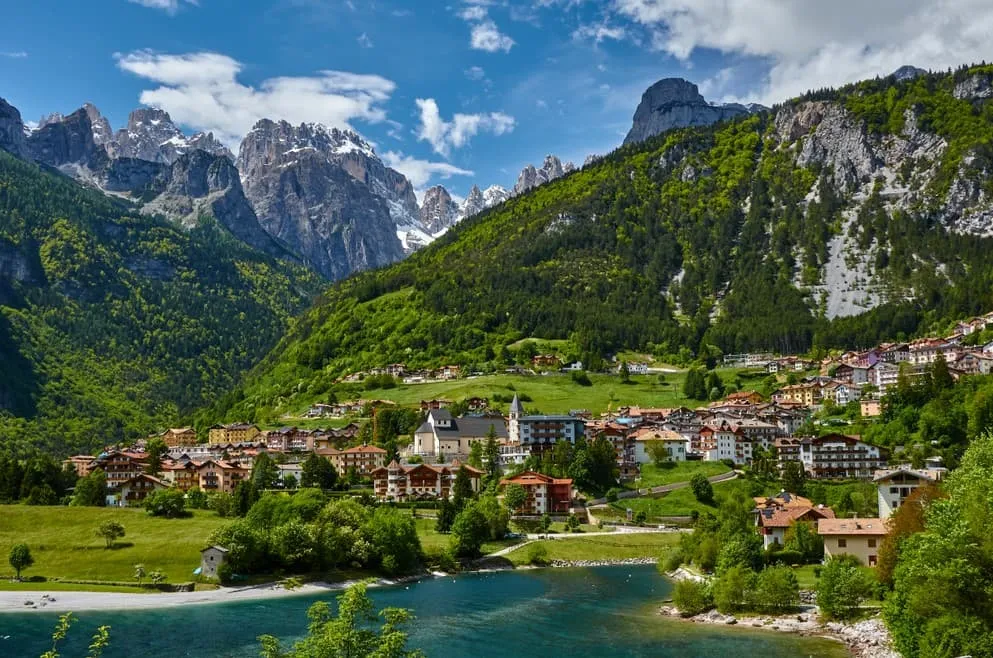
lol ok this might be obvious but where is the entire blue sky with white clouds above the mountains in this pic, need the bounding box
[0,0,993,195]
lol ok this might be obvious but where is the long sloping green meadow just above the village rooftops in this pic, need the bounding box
[293,373,697,416]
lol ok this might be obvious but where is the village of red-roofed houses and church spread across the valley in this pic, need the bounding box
[56,314,993,566]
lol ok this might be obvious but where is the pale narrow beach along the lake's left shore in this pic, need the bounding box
[0,580,376,613]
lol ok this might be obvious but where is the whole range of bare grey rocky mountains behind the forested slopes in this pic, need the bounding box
[0,79,754,280]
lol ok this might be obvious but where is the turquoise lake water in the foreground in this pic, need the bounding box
[0,566,847,658]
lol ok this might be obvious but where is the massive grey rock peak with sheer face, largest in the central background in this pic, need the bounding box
[238,120,403,279]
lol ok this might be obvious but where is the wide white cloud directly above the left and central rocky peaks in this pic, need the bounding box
[115,51,396,148]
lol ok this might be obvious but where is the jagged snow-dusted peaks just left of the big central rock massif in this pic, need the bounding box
[113,108,234,164]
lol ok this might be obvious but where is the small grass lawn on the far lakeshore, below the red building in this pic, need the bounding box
[507,533,680,565]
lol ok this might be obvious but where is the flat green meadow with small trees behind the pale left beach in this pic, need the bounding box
[0,505,230,590]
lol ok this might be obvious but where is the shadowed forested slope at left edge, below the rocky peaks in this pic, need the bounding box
[0,151,320,454]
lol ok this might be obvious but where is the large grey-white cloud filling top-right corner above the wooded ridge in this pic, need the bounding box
[613,0,993,103]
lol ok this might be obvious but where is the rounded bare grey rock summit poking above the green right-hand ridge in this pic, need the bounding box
[624,78,764,144]
